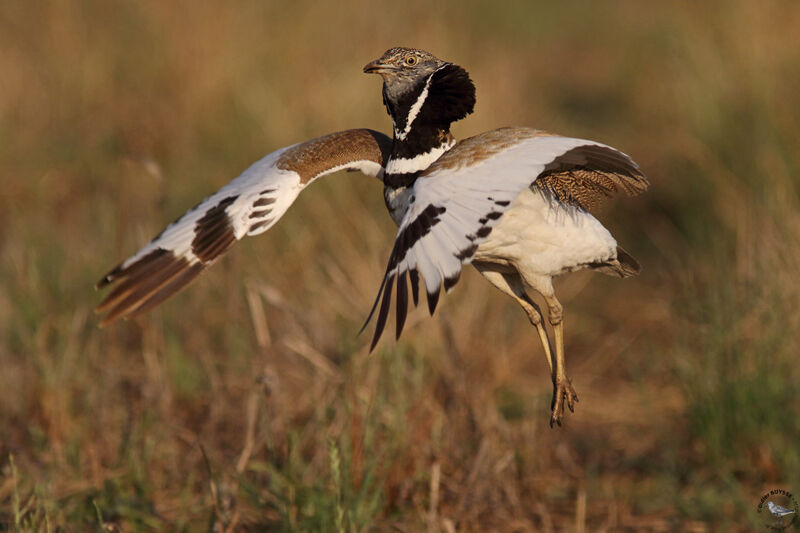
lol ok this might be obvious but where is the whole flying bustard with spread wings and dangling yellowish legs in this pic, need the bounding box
[97,47,648,426]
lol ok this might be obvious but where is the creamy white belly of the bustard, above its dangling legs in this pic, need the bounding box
[475,189,617,276]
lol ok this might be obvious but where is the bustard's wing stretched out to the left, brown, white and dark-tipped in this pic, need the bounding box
[95,129,392,326]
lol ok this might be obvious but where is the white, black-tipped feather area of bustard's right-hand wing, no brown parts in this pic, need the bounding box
[365,130,632,349]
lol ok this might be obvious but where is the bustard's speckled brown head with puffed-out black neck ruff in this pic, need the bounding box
[364,47,475,131]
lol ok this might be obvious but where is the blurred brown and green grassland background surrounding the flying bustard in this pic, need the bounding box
[0,0,800,531]
